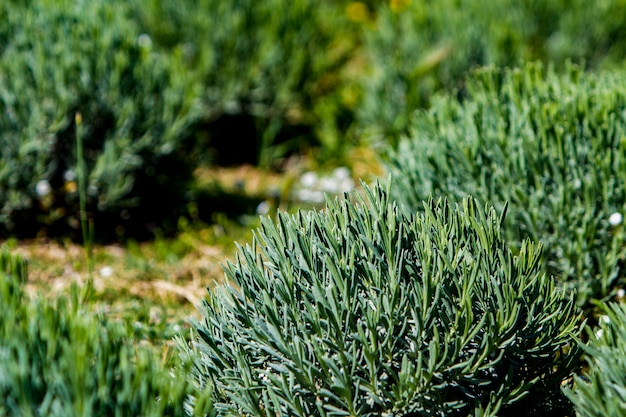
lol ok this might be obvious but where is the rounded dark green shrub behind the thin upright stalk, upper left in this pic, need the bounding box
[0,0,200,234]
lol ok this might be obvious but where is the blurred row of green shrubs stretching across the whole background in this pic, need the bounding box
[6,0,626,235]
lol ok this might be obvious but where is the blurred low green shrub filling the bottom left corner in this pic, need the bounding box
[0,255,211,417]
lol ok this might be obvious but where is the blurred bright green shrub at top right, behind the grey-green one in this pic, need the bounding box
[357,0,626,143]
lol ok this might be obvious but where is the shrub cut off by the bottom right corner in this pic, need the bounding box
[566,303,626,417]
